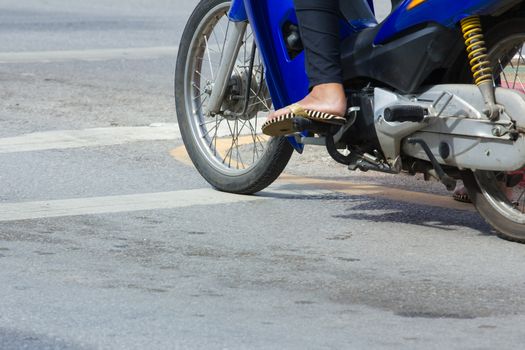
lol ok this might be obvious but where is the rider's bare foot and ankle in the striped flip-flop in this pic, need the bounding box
[267,83,346,120]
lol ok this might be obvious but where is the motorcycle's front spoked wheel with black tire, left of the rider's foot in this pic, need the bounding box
[175,0,293,194]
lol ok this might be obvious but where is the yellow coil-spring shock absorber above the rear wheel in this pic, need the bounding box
[461,16,500,120]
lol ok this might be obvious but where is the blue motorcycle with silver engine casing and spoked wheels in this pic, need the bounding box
[175,0,525,243]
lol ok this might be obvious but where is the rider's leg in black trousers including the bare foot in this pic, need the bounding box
[269,0,346,119]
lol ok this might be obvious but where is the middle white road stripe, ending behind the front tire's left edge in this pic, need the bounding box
[0,123,180,153]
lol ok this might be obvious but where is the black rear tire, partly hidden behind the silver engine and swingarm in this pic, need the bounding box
[462,18,525,243]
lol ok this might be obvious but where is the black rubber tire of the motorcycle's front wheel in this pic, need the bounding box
[175,0,293,194]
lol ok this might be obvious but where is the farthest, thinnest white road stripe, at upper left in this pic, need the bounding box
[0,46,178,64]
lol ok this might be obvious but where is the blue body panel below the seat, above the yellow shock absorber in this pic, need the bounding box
[375,0,512,45]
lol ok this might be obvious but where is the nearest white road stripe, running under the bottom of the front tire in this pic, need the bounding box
[0,188,264,222]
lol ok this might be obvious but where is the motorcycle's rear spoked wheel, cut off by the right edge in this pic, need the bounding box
[463,19,525,243]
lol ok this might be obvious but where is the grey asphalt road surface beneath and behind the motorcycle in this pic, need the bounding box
[0,0,525,349]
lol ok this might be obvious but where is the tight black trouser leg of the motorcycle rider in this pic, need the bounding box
[294,0,343,88]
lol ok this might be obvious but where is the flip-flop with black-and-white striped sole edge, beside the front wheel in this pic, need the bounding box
[262,103,346,136]
